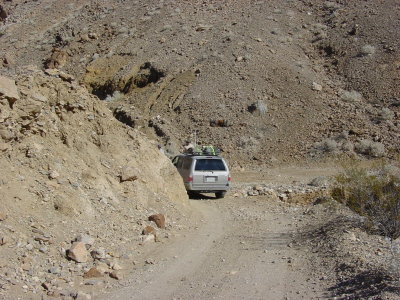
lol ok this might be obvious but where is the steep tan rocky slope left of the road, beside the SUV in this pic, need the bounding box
[0,70,190,297]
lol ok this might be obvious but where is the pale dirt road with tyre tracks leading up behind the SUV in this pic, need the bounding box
[95,168,334,299]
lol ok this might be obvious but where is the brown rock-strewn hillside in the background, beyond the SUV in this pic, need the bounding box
[1,1,400,165]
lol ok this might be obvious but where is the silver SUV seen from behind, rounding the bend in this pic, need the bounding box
[172,154,231,198]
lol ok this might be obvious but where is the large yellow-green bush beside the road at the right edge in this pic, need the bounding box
[331,165,400,240]
